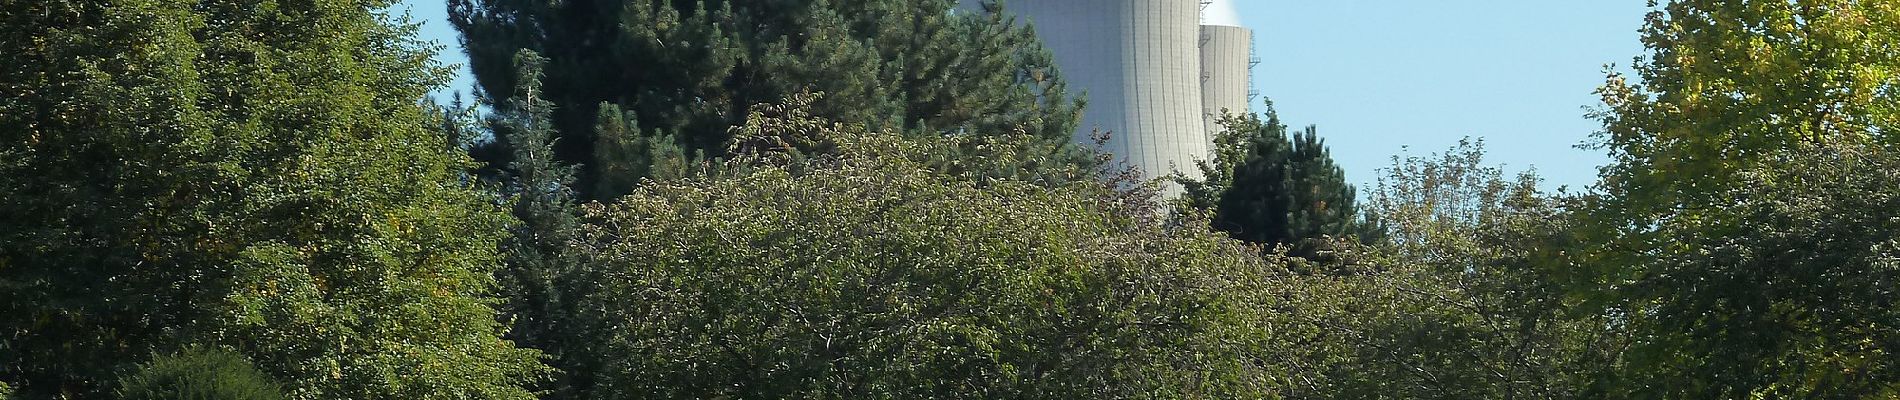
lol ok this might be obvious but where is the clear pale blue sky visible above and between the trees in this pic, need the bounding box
[399,0,1649,188]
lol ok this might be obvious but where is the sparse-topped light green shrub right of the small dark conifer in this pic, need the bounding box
[1290,142,1621,398]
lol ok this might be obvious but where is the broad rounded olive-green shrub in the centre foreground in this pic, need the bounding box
[562,102,1275,398]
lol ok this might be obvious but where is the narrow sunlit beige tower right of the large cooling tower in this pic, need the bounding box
[1201,25,1254,146]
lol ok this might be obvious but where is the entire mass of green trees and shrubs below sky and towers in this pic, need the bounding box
[0,0,1900,400]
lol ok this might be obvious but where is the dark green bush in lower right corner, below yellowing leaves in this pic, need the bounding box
[1588,146,1900,398]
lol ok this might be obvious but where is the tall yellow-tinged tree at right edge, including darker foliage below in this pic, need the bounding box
[1573,0,1900,398]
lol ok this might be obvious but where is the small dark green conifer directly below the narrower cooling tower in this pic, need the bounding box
[1174,102,1362,256]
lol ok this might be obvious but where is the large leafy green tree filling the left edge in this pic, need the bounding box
[0,0,542,398]
